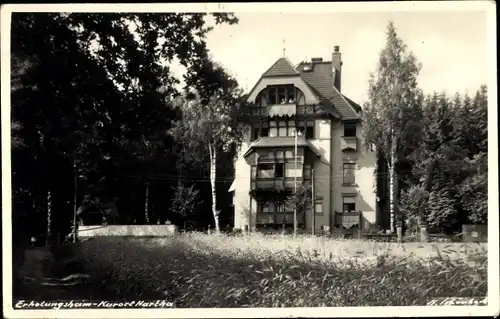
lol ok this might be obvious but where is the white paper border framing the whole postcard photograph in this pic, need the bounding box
[1,1,500,318]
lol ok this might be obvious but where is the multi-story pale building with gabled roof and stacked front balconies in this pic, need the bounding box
[230,46,381,234]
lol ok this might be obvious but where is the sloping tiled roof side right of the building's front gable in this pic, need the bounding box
[297,62,360,120]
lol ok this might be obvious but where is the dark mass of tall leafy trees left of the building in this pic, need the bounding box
[11,13,244,244]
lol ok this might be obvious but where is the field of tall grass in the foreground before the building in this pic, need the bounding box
[79,234,487,307]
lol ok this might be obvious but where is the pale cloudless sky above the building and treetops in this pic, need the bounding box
[172,11,488,103]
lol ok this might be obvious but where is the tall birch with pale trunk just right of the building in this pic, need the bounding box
[363,22,422,231]
